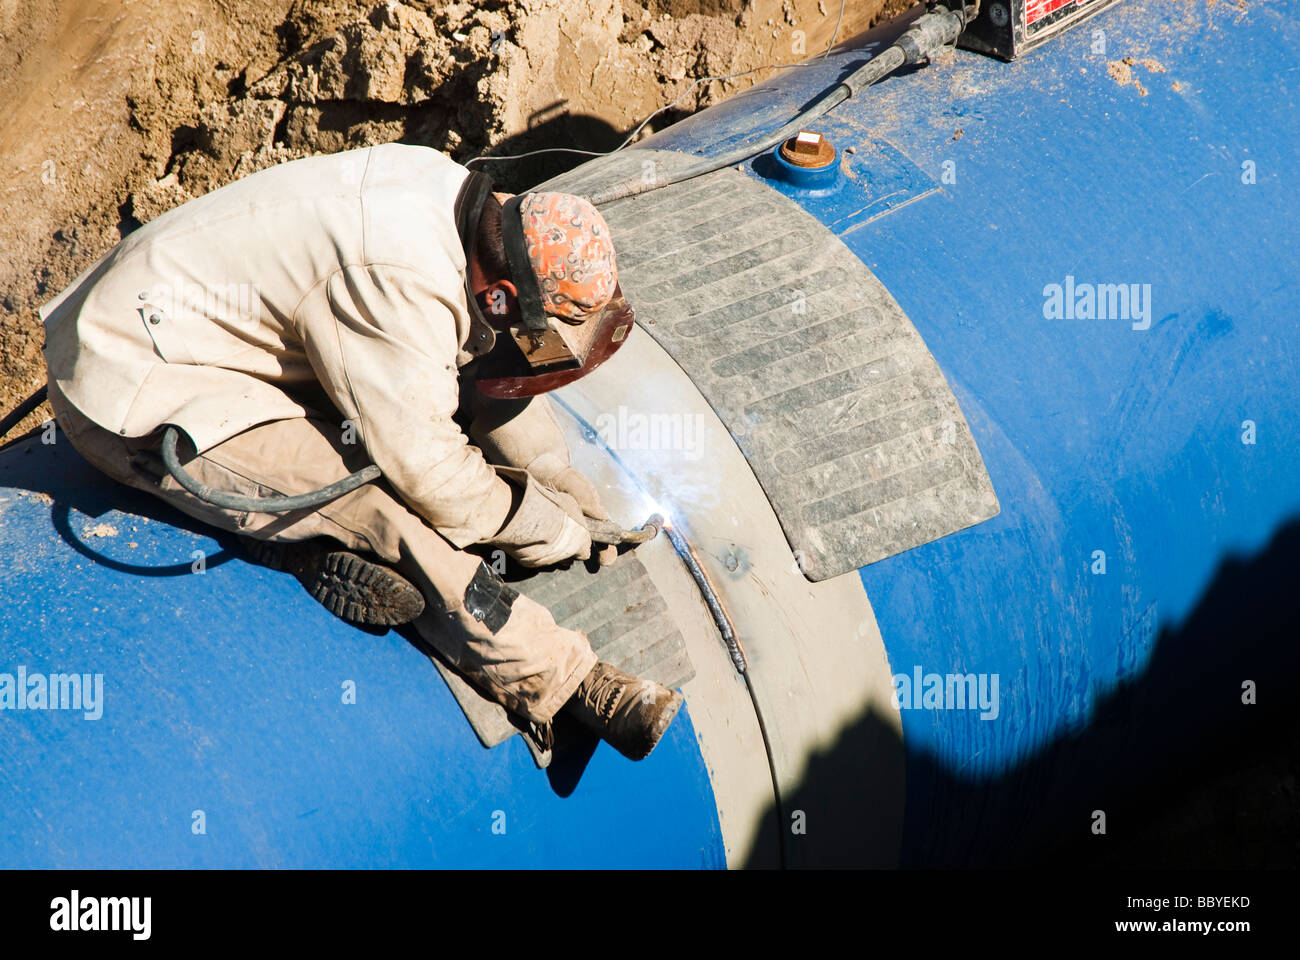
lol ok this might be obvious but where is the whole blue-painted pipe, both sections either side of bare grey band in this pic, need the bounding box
[0,0,1300,866]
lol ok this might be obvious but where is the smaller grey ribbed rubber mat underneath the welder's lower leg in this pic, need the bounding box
[432,553,696,766]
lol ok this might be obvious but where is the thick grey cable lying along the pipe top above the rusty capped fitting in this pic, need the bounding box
[588,3,979,206]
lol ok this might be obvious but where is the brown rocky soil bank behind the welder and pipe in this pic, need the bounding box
[0,0,911,436]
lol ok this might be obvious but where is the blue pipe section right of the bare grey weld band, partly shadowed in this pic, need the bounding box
[626,0,1300,864]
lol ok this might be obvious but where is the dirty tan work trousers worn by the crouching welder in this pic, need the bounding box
[49,384,597,723]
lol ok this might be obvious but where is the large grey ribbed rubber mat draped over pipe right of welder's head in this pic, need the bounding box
[545,150,998,580]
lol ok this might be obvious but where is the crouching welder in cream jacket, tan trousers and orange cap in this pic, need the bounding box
[42,144,681,760]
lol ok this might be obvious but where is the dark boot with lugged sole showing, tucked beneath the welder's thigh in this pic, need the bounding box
[239,536,424,627]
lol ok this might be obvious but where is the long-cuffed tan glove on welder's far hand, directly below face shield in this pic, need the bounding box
[469,397,610,520]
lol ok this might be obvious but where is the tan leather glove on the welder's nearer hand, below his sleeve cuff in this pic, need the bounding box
[486,467,592,567]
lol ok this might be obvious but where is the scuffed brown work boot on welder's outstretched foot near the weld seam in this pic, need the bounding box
[564,660,683,760]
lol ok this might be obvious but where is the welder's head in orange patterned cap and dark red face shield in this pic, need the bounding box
[469,174,633,399]
